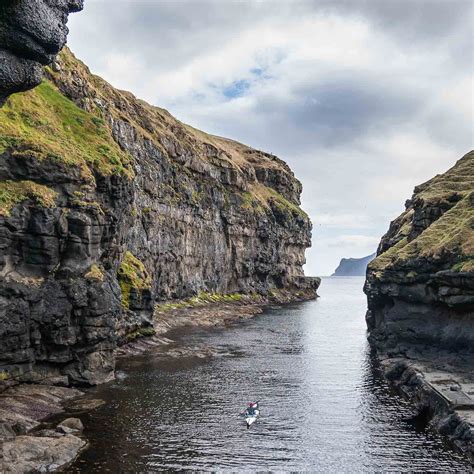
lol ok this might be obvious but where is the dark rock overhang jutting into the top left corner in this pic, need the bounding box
[0,0,83,106]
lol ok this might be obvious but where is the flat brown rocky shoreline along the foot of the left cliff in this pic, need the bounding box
[0,290,318,472]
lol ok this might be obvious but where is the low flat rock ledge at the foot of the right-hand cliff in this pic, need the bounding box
[377,353,474,465]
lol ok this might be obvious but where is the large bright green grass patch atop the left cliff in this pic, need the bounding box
[0,81,133,180]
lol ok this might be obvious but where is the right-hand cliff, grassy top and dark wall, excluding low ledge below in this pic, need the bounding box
[365,151,474,356]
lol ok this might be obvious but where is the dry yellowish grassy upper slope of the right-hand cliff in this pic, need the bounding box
[369,151,474,276]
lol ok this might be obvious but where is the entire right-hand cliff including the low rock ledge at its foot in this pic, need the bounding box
[364,151,474,462]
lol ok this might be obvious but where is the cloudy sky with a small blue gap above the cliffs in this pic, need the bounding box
[69,0,474,275]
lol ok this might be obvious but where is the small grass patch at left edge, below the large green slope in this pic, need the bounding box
[0,181,57,216]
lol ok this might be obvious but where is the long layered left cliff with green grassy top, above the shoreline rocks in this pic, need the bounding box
[0,50,317,383]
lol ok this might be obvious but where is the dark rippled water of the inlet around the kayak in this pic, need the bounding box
[69,278,469,472]
